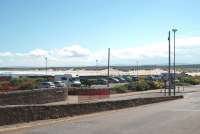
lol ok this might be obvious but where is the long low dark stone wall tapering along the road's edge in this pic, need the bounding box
[0,96,183,125]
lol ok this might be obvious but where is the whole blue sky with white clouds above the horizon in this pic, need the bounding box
[0,0,200,67]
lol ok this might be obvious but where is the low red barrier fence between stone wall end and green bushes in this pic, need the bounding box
[78,89,110,103]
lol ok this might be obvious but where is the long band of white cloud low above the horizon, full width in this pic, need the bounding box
[0,37,200,66]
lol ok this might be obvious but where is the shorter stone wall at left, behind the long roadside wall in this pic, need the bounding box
[0,89,67,105]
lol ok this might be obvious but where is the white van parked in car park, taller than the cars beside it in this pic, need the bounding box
[54,74,81,87]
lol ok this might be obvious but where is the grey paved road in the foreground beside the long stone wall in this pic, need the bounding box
[2,86,200,134]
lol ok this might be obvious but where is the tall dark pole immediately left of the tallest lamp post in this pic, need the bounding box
[168,31,171,96]
